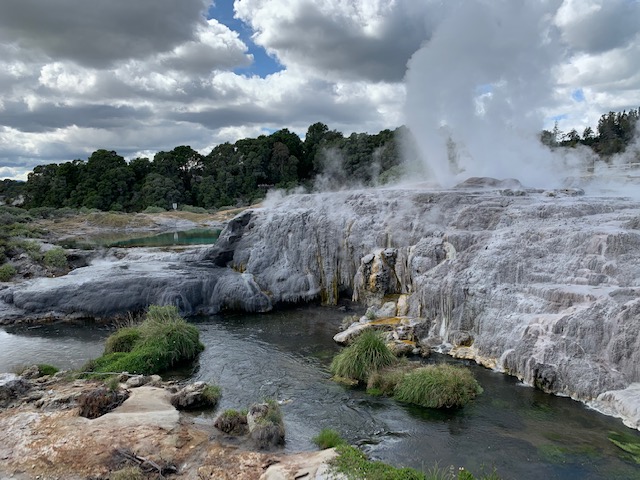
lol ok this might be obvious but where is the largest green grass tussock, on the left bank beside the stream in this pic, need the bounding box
[84,305,204,375]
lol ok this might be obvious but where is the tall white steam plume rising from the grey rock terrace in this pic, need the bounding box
[406,0,569,187]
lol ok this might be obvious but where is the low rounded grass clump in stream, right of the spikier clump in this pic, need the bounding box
[394,364,482,408]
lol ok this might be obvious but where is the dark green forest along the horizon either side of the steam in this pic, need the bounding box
[0,108,640,211]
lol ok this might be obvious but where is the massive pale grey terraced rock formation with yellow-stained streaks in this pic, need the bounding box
[0,183,640,428]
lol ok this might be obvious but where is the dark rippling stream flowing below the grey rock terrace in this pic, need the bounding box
[0,307,640,480]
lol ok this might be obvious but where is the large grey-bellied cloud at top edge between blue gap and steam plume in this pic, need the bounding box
[235,0,432,82]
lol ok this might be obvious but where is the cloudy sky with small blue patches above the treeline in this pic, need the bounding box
[0,0,640,179]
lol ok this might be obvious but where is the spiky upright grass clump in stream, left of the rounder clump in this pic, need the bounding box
[330,329,397,382]
